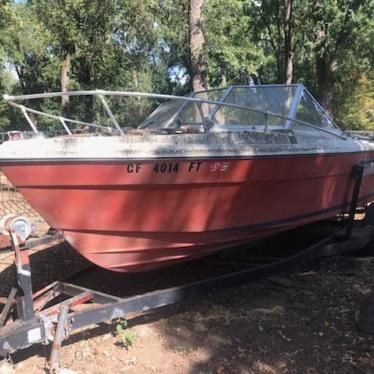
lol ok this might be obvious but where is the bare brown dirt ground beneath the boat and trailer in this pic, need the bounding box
[0,238,374,374]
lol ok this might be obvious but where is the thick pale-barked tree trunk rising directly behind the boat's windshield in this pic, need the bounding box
[188,0,207,91]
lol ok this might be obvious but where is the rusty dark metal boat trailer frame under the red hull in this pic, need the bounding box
[0,161,374,373]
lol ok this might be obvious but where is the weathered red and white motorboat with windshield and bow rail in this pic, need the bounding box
[0,84,374,272]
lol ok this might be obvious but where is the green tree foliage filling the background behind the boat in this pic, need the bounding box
[0,0,374,130]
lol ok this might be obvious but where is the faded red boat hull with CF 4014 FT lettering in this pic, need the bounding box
[1,152,374,271]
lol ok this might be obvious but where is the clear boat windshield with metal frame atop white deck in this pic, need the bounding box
[140,85,336,129]
